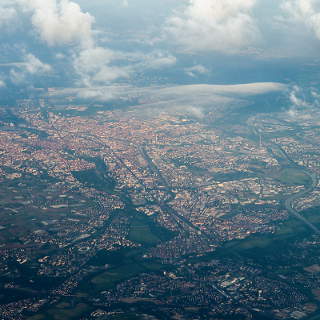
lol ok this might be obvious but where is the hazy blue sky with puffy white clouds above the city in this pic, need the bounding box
[0,0,320,107]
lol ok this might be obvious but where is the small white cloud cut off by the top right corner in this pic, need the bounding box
[281,0,320,40]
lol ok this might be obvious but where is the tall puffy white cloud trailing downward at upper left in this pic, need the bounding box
[15,0,129,87]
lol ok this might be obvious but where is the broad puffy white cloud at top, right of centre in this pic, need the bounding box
[167,0,259,53]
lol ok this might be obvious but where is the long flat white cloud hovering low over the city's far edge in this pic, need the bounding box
[139,82,287,118]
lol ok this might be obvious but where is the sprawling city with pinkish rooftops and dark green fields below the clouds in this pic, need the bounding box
[0,93,320,320]
